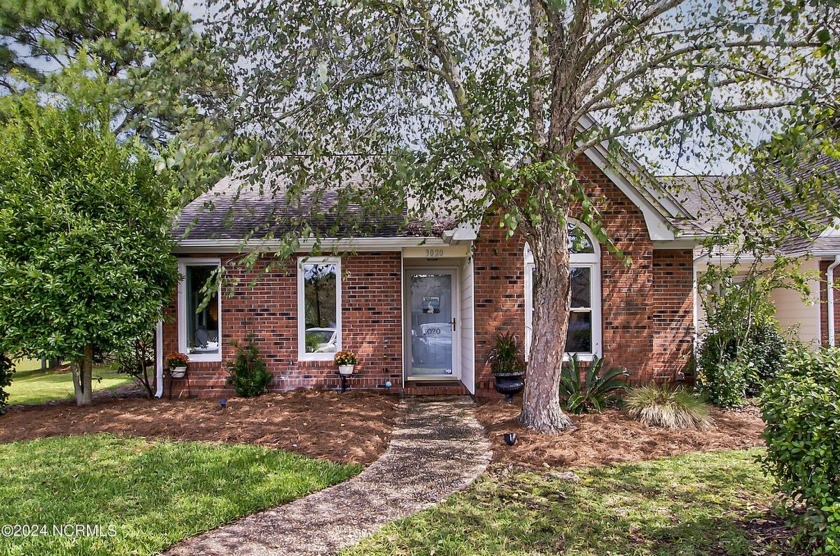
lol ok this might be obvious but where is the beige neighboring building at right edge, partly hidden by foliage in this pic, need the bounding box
[668,156,840,346]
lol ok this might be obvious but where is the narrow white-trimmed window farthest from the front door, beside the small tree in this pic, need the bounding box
[178,258,222,362]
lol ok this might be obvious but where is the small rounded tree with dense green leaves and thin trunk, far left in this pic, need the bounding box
[0,94,177,405]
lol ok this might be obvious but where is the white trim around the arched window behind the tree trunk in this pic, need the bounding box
[525,218,603,361]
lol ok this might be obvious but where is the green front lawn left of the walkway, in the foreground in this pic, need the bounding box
[0,434,362,555]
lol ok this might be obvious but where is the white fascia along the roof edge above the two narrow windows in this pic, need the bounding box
[173,237,449,253]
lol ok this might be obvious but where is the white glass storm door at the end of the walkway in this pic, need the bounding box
[409,273,452,376]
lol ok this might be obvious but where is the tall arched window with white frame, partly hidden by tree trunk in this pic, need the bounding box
[525,219,601,361]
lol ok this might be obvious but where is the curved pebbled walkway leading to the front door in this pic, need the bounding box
[167,397,491,555]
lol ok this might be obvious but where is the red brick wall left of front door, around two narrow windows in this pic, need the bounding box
[163,253,402,396]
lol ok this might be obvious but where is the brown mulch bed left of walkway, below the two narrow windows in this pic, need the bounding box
[0,391,399,464]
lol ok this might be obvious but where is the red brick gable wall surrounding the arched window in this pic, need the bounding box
[474,154,693,396]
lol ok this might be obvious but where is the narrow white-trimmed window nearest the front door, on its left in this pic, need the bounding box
[298,257,341,361]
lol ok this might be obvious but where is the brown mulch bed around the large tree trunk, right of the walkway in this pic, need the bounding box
[476,400,764,467]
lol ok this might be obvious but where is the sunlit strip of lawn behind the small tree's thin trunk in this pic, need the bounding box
[6,360,133,404]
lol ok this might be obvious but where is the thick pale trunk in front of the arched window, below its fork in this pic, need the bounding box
[519,216,574,433]
